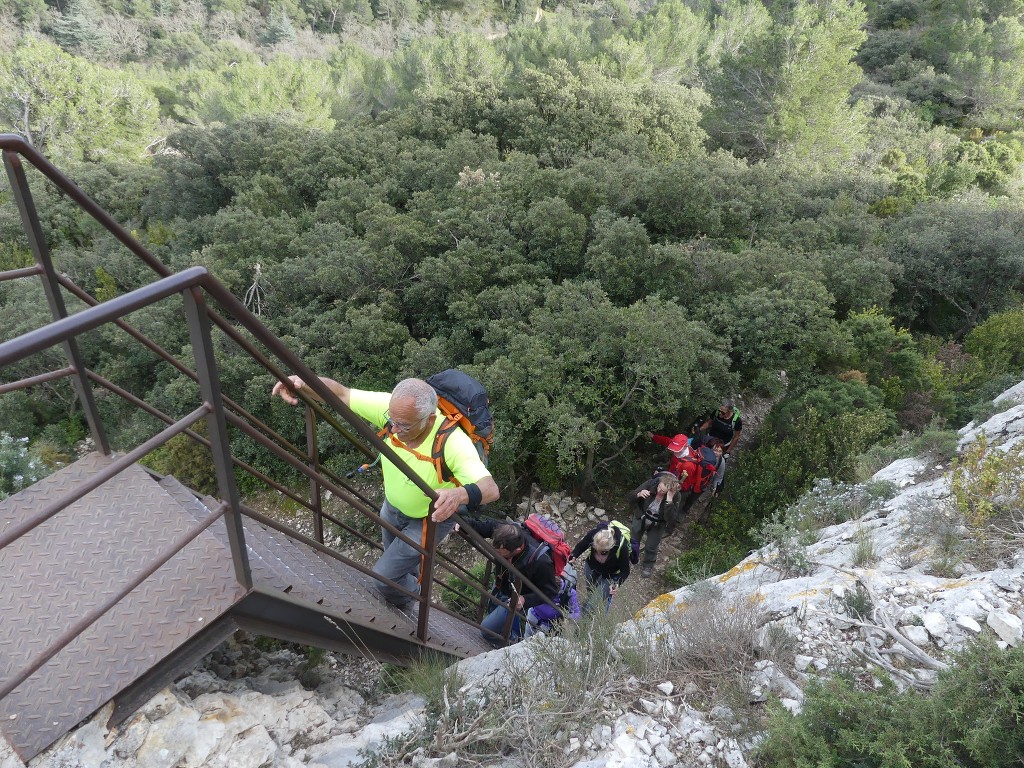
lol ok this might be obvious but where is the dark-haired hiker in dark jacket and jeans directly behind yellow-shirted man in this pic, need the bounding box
[466,519,559,648]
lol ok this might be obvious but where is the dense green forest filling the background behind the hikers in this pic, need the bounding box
[0,0,1024,536]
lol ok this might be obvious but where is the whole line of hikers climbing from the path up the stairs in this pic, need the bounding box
[271,371,742,647]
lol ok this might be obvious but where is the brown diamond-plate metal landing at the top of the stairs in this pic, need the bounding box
[0,454,246,760]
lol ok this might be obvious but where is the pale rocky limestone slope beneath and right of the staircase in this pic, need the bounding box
[8,383,1024,768]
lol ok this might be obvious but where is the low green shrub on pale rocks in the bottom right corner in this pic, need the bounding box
[757,639,1024,768]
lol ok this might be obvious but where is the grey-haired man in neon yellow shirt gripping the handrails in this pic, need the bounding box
[270,376,499,609]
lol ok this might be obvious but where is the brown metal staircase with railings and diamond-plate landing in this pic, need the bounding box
[0,135,548,761]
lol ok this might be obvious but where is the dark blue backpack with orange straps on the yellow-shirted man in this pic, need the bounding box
[381,368,495,485]
